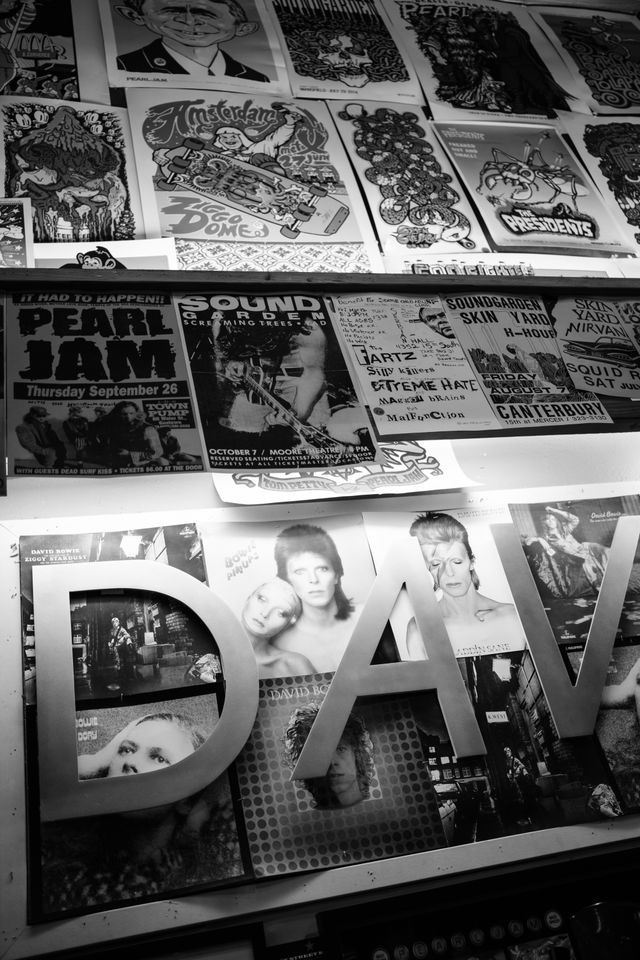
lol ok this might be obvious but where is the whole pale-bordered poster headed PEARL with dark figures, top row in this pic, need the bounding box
[382,0,581,120]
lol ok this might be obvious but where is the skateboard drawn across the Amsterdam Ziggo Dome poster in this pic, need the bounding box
[156,137,350,240]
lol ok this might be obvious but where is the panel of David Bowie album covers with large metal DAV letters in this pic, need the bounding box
[20,496,640,921]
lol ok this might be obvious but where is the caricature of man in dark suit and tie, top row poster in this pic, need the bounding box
[115,0,269,83]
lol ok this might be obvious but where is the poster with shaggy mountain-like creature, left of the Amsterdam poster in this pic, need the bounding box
[0,97,143,243]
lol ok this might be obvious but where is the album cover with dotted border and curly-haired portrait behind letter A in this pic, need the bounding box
[232,673,446,877]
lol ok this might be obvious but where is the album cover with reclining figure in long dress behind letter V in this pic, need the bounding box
[509,496,640,645]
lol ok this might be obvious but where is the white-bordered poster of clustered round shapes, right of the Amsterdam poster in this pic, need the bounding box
[329,101,489,262]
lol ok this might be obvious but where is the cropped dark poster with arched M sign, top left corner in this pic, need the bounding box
[0,0,79,100]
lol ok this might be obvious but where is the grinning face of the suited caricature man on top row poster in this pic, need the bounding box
[119,0,257,47]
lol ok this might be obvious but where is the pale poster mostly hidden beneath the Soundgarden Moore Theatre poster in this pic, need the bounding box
[212,440,475,506]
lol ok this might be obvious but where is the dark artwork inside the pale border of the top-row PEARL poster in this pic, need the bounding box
[403,3,572,115]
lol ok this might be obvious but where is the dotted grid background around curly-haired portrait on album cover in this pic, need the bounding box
[232,674,446,877]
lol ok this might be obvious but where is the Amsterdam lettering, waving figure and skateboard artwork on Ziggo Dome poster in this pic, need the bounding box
[143,101,350,240]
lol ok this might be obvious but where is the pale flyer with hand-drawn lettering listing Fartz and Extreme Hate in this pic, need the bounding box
[332,293,502,437]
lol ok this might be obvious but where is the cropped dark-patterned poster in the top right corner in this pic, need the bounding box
[531,5,640,114]
